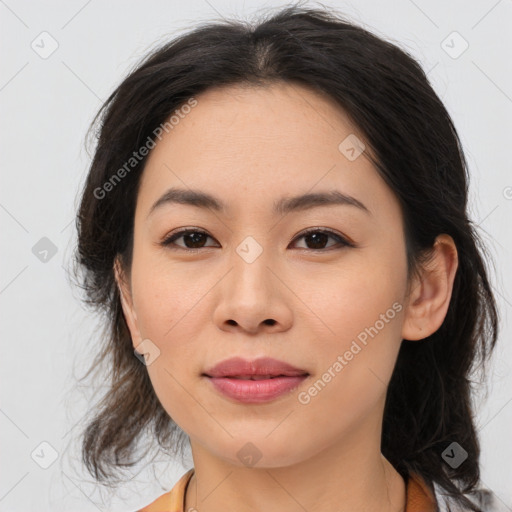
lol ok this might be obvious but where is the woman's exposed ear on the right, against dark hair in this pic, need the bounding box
[402,234,458,340]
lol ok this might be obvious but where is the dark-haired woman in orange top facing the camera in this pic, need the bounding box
[77,6,498,512]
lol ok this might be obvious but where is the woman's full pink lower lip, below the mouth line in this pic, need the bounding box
[208,375,307,403]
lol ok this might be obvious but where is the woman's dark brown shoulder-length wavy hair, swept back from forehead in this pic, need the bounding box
[75,5,498,510]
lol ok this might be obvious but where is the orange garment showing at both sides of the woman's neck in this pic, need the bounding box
[138,468,437,512]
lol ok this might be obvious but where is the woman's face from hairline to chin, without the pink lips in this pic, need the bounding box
[117,84,407,467]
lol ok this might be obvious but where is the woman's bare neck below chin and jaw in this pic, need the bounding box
[185,428,406,512]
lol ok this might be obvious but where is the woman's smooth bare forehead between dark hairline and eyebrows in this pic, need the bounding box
[137,83,392,220]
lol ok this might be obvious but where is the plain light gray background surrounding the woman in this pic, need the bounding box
[0,0,512,512]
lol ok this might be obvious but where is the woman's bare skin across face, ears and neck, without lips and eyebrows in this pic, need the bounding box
[115,84,457,512]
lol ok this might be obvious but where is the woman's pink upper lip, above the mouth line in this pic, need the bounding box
[203,357,309,377]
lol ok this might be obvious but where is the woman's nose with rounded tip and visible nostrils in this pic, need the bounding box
[214,254,293,335]
